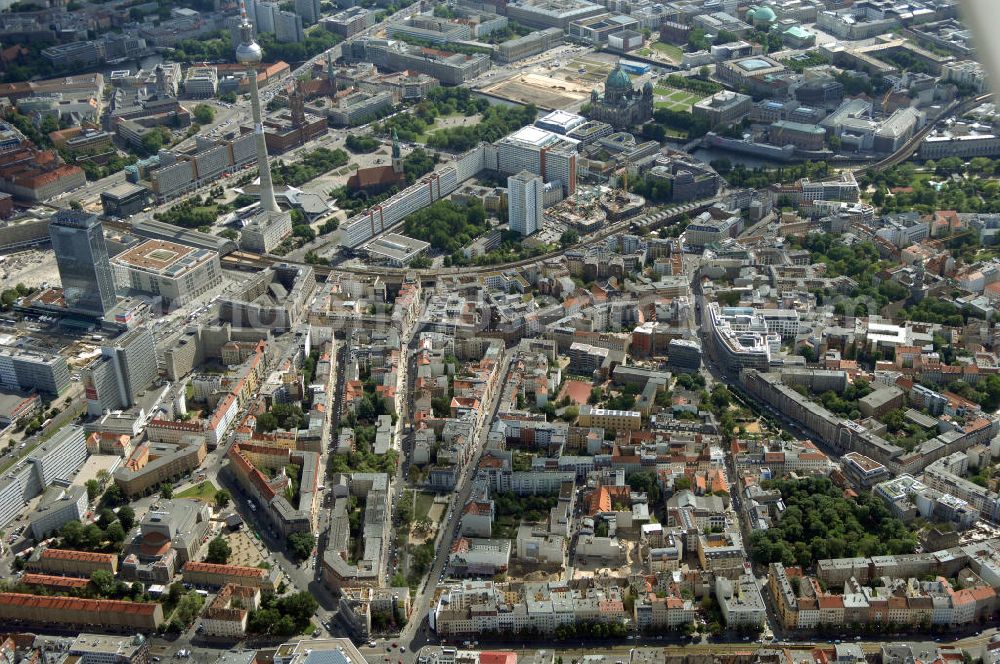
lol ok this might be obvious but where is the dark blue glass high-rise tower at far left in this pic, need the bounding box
[49,211,118,317]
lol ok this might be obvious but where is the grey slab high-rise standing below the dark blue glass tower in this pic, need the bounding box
[83,327,159,416]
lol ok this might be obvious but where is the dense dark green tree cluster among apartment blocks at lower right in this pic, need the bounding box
[750,477,916,567]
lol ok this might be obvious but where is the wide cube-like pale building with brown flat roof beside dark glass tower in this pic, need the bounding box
[111,240,222,307]
